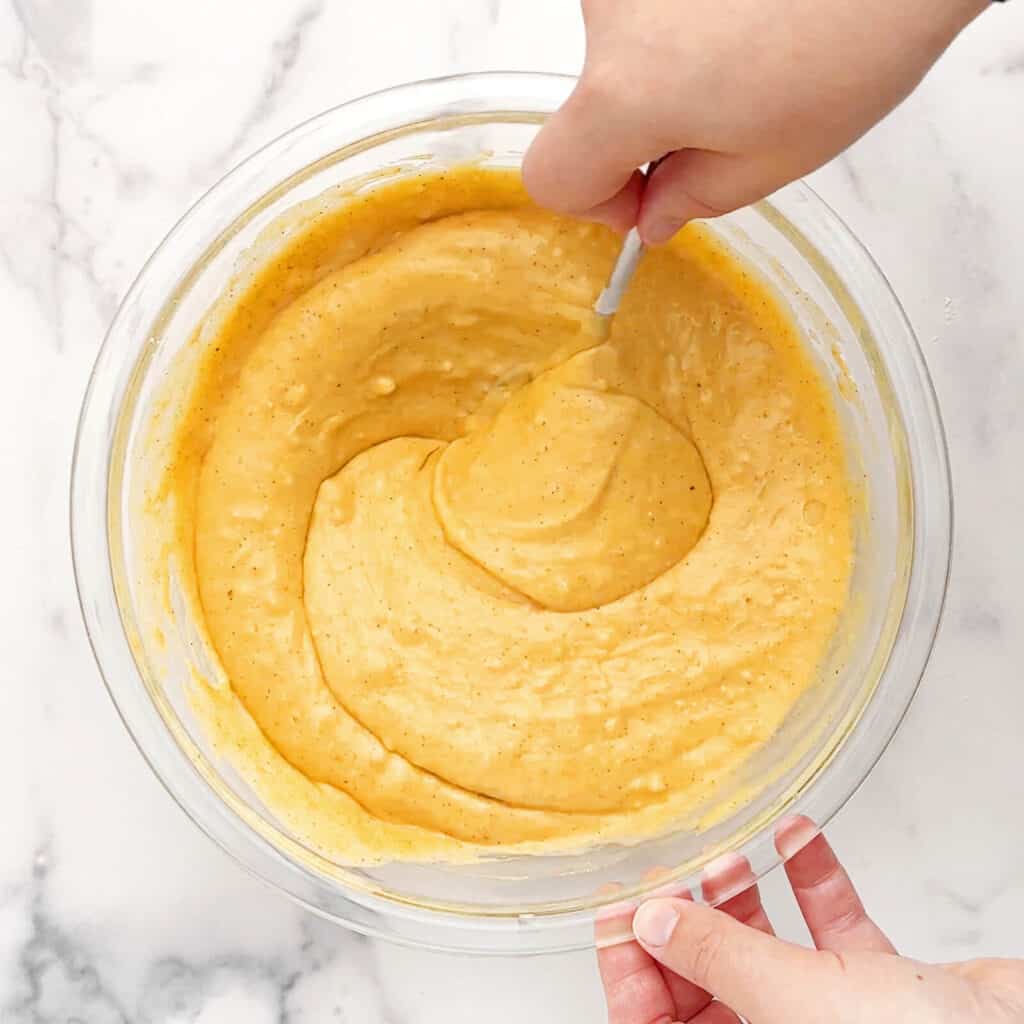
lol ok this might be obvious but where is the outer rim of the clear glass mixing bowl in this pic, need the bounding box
[71,72,952,954]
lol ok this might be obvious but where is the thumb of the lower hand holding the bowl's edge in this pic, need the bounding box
[633,899,827,1024]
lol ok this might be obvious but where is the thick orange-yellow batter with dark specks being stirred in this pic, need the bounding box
[159,168,852,862]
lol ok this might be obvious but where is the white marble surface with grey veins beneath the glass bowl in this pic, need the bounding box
[0,0,1024,1024]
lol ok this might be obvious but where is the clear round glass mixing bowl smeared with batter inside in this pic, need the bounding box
[72,74,951,953]
